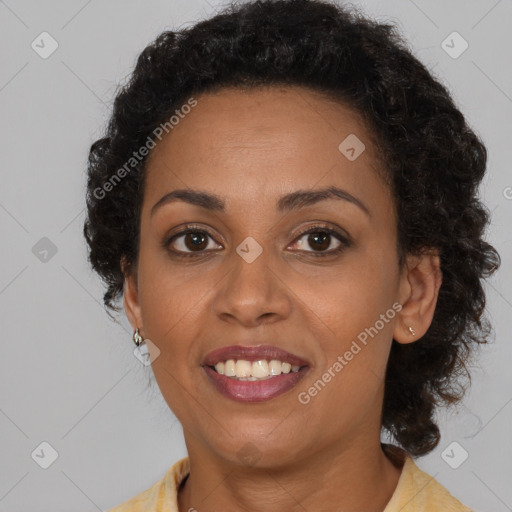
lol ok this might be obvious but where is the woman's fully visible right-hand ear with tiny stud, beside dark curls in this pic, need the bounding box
[393,249,443,343]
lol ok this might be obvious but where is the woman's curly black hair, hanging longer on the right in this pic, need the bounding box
[84,0,500,456]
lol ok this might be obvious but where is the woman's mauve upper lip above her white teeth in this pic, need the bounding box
[203,345,309,366]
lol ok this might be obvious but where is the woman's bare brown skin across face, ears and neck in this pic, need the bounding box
[123,86,442,512]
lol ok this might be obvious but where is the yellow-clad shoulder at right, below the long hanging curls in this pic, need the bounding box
[384,455,474,512]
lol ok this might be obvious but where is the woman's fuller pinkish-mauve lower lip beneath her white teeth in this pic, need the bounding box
[203,366,308,402]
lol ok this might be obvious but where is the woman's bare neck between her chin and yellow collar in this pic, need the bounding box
[178,439,403,512]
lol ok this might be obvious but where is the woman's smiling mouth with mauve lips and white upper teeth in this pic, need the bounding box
[201,345,310,402]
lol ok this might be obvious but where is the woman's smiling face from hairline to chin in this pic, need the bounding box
[125,87,409,465]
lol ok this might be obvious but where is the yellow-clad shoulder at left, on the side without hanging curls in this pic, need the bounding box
[107,457,190,512]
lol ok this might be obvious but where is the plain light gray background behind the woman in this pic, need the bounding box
[0,0,512,512]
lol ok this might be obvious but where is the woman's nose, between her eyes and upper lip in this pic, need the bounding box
[213,245,292,327]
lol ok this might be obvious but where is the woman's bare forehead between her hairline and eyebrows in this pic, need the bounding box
[144,87,387,216]
